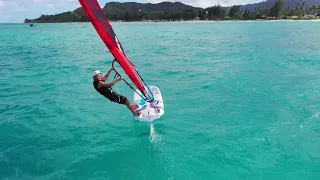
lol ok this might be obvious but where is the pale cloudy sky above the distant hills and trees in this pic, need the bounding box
[0,0,265,23]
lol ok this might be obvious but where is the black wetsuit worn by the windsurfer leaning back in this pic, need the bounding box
[93,81,127,104]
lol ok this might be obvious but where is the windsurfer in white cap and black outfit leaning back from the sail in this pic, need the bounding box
[92,66,139,116]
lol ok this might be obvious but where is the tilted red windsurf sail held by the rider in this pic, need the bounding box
[79,0,153,101]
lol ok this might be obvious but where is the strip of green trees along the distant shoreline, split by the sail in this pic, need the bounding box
[25,0,320,22]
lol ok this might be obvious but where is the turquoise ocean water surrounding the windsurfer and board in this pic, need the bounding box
[0,21,320,180]
